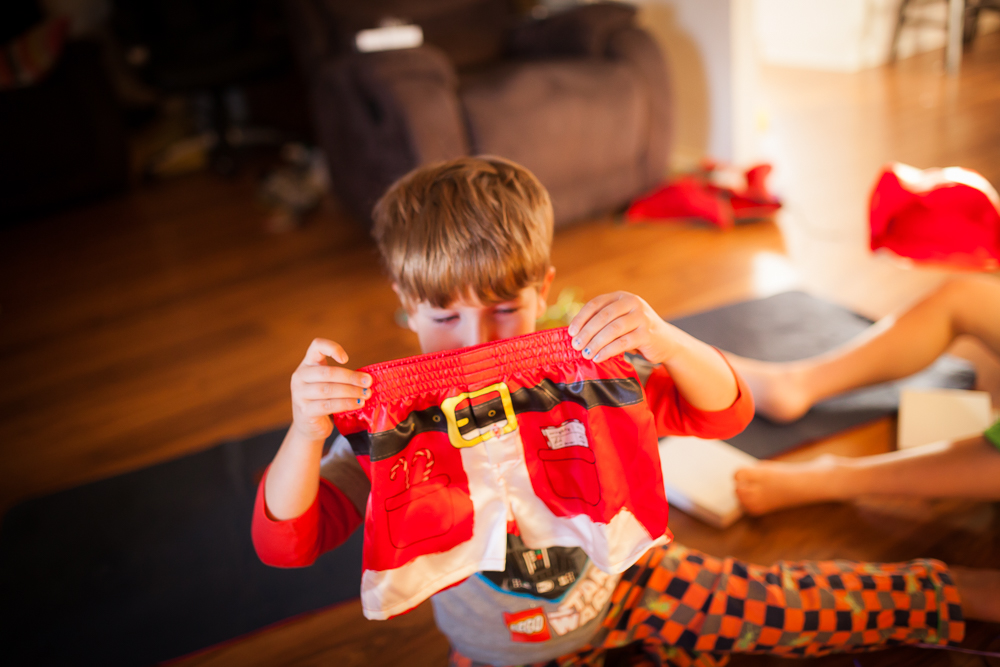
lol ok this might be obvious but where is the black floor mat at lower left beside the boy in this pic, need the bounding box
[0,429,363,665]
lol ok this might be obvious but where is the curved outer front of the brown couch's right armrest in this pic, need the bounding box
[607,26,674,189]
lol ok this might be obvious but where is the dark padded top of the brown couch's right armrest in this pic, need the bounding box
[509,2,636,58]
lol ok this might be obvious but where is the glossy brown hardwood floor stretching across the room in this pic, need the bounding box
[0,33,1000,667]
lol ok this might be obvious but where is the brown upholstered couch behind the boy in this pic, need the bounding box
[289,0,671,225]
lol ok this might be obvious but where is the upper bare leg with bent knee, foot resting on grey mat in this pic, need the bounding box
[726,276,1000,422]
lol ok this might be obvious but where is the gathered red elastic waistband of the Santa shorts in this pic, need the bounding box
[359,327,585,402]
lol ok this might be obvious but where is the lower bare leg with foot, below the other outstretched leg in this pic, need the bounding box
[736,436,1000,514]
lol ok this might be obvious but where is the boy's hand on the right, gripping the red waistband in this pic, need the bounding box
[569,292,680,364]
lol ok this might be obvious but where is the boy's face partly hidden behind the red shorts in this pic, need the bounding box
[398,268,555,354]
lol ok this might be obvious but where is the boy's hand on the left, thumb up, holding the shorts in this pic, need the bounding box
[292,338,372,440]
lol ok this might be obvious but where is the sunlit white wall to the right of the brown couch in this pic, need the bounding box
[624,0,1000,171]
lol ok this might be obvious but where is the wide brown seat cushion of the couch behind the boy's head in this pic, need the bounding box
[459,59,649,210]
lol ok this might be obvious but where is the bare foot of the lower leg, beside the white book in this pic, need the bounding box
[734,454,839,515]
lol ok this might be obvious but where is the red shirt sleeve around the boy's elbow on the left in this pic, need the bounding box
[251,464,361,567]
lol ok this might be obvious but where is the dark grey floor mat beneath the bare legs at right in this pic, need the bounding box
[671,292,976,458]
